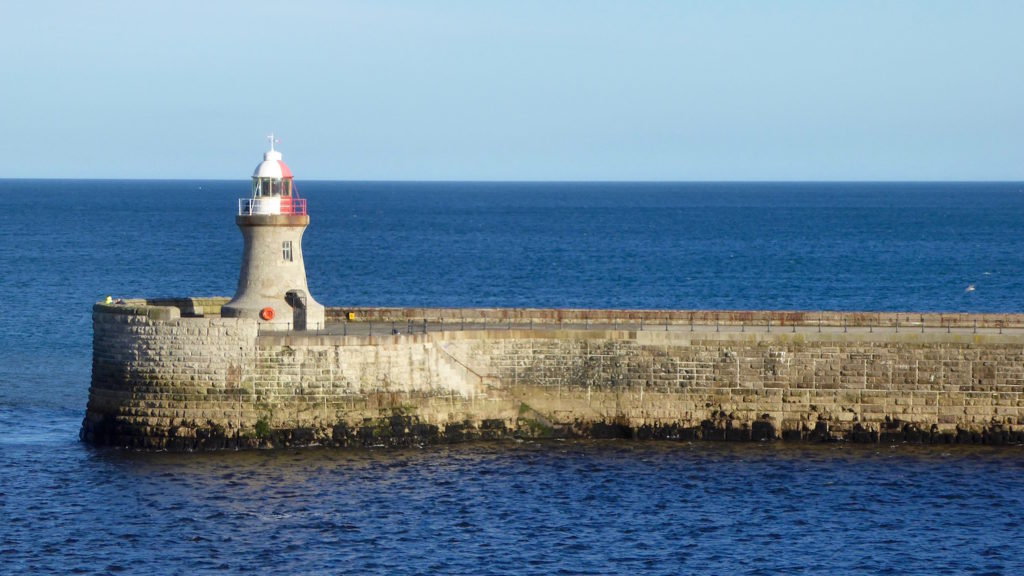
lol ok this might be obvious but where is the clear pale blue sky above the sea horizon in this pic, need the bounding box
[0,0,1024,180]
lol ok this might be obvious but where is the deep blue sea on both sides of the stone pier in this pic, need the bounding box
[0,180,1024,574]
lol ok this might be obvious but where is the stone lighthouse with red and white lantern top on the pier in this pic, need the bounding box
[221,134,324,330]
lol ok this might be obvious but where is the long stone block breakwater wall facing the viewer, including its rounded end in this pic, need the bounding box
[82,299,1024,450]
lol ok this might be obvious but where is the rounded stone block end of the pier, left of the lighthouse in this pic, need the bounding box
[82,299,257,449]
